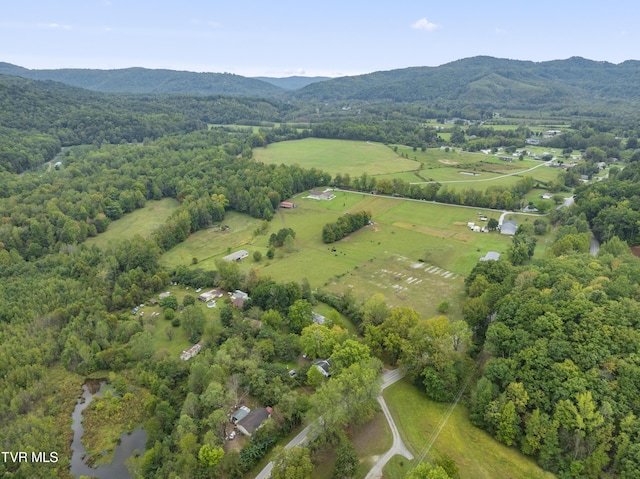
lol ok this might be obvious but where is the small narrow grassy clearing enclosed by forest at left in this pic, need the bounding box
[86,198,179,248]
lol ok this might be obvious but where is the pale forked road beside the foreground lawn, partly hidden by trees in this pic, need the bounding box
[256,369,413,479]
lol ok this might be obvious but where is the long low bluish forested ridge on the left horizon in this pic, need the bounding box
[0,63,282,98]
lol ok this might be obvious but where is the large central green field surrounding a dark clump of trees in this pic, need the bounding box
[161,191,511,319]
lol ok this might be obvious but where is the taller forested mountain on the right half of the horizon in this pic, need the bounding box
[295,57,640,109]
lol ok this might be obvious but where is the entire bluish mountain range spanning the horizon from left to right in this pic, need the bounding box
[0,56,640,113]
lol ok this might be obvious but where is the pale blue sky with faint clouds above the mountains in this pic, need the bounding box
[0,0,640,77]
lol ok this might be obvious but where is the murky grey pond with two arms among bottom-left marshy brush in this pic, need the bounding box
[71,379,147,479]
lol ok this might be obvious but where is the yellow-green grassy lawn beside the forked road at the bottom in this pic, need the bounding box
[384,381,554,479]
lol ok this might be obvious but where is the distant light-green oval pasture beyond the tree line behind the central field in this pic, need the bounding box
[253,138,420,177]
